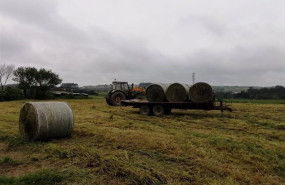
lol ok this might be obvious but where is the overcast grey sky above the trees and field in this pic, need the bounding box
[0,0,285,86]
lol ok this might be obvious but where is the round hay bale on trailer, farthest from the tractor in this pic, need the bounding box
[189,82,214,103]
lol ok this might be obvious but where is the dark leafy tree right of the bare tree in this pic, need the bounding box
[13,67,62,98]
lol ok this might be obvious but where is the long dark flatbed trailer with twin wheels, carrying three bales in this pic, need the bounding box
[121,99,232,116]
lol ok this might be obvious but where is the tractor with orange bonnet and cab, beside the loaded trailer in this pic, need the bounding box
[105,81,145,106]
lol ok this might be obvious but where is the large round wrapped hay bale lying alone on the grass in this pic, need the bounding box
[19,102,74,140]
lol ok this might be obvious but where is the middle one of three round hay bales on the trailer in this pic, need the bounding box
[165,83,189,102]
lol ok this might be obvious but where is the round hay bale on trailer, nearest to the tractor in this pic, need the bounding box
[145,84,170,102]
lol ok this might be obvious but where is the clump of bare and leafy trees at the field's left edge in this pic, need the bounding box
[0,64,62,101]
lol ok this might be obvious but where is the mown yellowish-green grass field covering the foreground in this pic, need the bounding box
[0,98,285,185]
